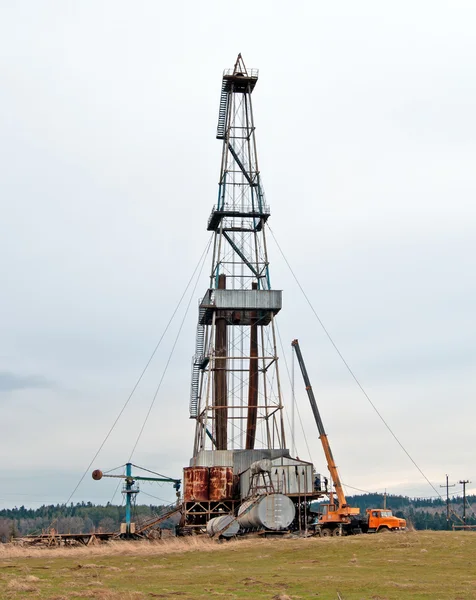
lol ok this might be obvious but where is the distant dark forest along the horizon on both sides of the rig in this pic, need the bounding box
[0,494,476,542]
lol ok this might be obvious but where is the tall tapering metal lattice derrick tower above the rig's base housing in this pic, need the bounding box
[190,55,285,456]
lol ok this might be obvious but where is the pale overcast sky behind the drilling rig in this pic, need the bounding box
[0,0,476,507]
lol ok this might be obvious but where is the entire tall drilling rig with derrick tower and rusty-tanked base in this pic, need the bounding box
[182,54,321,530]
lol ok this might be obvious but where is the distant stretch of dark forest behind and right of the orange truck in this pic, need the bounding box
[347,494,476,530]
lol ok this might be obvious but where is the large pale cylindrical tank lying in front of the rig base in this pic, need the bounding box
[236,494,296,531]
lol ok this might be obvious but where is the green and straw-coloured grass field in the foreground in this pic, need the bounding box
[0,532,476,600]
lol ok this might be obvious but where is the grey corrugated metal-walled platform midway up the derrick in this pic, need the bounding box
[200,290,283,325]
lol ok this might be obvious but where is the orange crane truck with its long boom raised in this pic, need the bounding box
[292,340,406,536]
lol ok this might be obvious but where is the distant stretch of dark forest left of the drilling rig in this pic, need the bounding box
[0,502,174,542]
